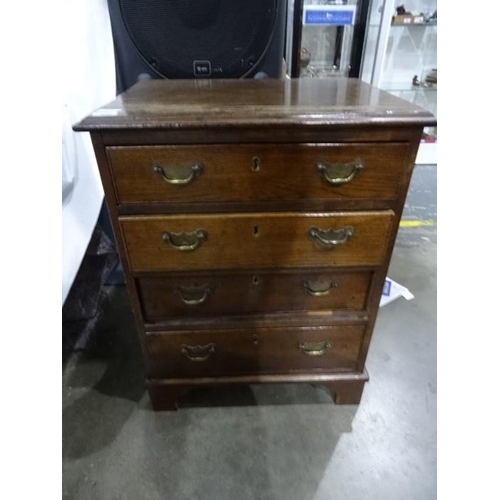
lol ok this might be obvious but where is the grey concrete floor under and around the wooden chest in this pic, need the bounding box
[62,166,436,500]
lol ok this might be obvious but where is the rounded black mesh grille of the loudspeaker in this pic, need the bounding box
[120,0,277,78]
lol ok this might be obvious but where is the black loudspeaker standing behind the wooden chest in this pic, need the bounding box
[108,0,286,94]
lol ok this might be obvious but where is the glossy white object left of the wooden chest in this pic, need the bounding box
[62,0,116,304]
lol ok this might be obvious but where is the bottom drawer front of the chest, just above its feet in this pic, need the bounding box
[147,325,365,377]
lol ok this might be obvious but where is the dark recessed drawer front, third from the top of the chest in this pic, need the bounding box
[137,270,372,323]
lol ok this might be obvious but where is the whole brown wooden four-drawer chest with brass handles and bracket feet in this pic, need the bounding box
[74,79,434,409]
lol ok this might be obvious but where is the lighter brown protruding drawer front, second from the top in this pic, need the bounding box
[120,210,394,271]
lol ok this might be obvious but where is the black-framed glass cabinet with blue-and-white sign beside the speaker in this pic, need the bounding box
[286,0,369,78]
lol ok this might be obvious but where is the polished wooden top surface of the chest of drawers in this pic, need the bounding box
[74,78,436,131]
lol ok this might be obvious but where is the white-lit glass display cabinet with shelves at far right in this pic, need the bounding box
[360,0,437,164]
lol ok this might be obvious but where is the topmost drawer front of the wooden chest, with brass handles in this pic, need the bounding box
[107,143,407,204]
